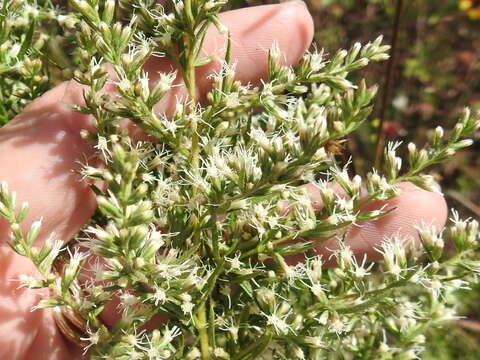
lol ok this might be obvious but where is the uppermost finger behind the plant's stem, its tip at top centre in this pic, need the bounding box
[146,1,314,115]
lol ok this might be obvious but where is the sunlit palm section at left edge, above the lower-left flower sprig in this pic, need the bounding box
[0,83,95,248]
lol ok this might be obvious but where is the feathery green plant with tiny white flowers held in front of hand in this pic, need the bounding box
[0,0,480,360]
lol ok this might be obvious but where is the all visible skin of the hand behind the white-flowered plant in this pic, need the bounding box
[0,2,447,360]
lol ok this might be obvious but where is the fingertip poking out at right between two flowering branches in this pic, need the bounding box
[316,183,448,266]
